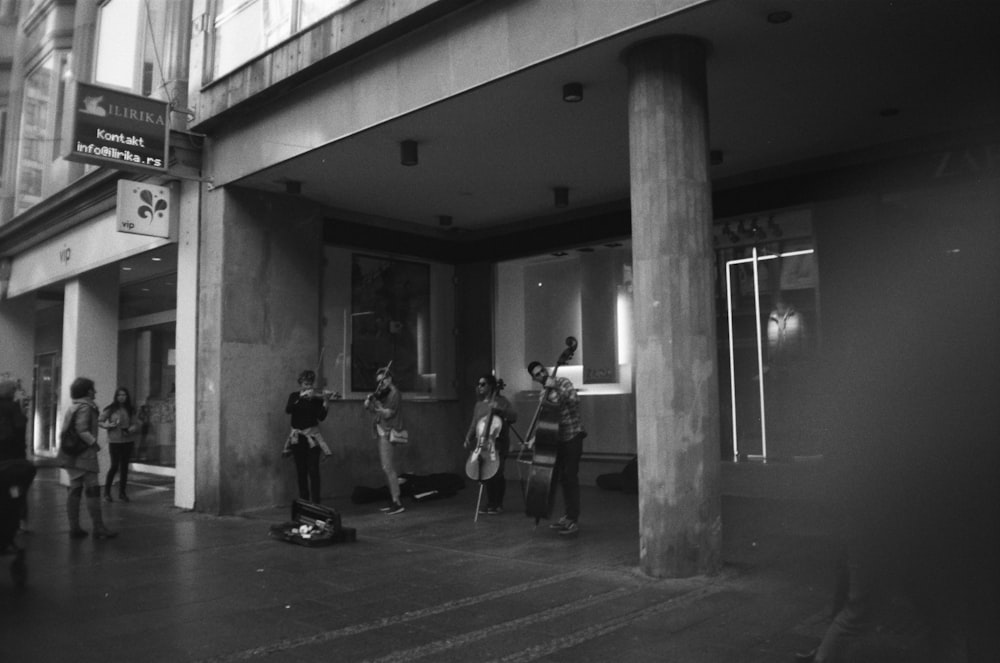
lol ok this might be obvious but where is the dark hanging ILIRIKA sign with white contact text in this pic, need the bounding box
[66,83,170,172]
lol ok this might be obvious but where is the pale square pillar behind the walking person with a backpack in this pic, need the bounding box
[59,264,119,480]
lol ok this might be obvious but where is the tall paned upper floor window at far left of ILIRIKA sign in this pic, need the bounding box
[14,51,69,214]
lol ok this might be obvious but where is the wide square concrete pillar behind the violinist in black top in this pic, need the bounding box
[195,190,320,514]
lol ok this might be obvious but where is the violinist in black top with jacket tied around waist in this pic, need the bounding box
[281,370,340,504]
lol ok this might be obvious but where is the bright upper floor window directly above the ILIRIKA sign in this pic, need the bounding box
[94,0,166,97]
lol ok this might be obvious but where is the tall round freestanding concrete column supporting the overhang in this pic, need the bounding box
[625,36,722,578]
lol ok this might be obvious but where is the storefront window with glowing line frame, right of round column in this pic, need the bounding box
[715,210,819,458]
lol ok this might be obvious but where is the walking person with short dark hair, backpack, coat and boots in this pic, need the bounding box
[56,377,118,539]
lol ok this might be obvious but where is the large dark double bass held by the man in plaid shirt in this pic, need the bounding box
[524,336,577,526]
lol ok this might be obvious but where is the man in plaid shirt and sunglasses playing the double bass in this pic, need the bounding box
[528,361,587,536]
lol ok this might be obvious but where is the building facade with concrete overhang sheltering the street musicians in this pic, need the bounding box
[0,0,1000,576]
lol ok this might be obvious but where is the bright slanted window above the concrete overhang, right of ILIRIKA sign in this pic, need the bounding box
[213,0,355,77]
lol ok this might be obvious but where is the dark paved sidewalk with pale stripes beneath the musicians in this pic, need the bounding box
[0,468,910,663]
